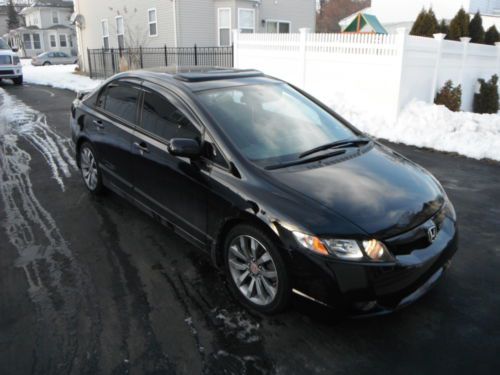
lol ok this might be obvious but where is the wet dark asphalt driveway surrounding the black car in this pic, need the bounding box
[0,83,500,374]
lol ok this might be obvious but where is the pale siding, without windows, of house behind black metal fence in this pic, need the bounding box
[75,0,316,69]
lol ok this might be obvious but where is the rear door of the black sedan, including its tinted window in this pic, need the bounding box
[88,79,141,193]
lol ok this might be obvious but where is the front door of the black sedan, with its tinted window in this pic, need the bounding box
[132,84,207,245]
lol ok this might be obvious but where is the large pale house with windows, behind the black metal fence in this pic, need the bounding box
[72,0,316,69]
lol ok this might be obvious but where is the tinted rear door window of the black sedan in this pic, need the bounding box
[99,83,140,124]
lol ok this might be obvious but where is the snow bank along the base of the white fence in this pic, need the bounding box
[331,96,500,161]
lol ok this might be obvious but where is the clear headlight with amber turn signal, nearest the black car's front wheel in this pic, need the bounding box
[293,231,393,262]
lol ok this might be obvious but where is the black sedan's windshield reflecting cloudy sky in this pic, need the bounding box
[198,84,357,166]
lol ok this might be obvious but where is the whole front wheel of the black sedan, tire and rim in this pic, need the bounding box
[224,224,291,315]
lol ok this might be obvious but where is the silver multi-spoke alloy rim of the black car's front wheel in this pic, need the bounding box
[228,235,278,306]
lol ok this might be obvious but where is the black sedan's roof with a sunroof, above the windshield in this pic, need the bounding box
[117,66,279,92]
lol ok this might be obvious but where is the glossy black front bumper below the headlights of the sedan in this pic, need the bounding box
[291,213,458,315]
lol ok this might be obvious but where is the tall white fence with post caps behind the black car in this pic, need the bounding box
[233,29,500,119]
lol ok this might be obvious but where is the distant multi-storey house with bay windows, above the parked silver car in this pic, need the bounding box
[9,0,77,57]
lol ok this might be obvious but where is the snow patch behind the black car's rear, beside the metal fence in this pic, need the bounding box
[23,60,102,91]
